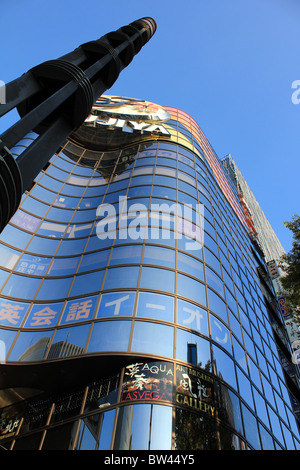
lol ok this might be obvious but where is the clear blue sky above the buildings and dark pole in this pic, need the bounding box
[0,0,300,255]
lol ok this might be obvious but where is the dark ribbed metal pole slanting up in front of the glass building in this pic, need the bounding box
[0,18,156,232]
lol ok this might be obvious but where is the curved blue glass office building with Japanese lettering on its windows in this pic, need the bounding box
[0,96,299,450]
